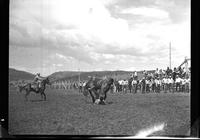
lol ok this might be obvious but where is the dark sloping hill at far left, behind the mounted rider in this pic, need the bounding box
[9,68,35,81]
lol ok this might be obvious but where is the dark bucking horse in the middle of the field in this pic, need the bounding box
[83,78,114,104]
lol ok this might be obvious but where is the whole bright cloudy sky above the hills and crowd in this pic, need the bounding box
[9,0,191,76]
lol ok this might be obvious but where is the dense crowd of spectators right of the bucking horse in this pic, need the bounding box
[112,67,191,93]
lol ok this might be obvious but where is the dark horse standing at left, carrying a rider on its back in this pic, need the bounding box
[18,77,51,101]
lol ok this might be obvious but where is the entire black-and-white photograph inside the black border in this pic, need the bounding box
[8,0,191,138]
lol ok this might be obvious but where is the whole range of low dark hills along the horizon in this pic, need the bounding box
[9,68,156,81]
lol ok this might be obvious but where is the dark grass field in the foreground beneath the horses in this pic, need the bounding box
[9,89,190,136]
